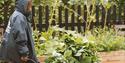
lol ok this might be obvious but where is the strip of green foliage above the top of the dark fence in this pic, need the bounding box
[33,0,124,5]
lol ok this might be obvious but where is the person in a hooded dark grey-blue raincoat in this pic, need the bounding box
[0,0,39,63]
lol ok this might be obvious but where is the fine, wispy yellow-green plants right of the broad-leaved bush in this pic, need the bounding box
[86,28,125,52]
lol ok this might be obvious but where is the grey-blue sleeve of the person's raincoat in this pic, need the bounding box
[13,16,29,56]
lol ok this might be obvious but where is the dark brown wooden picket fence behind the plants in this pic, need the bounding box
[0,5,125,32]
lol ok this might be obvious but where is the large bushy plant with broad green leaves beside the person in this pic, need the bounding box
[36,27,98,63]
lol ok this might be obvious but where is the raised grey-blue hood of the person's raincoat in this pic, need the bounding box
[16,0,29,16]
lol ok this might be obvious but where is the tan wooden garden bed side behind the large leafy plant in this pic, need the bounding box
[39,50,125,63]
